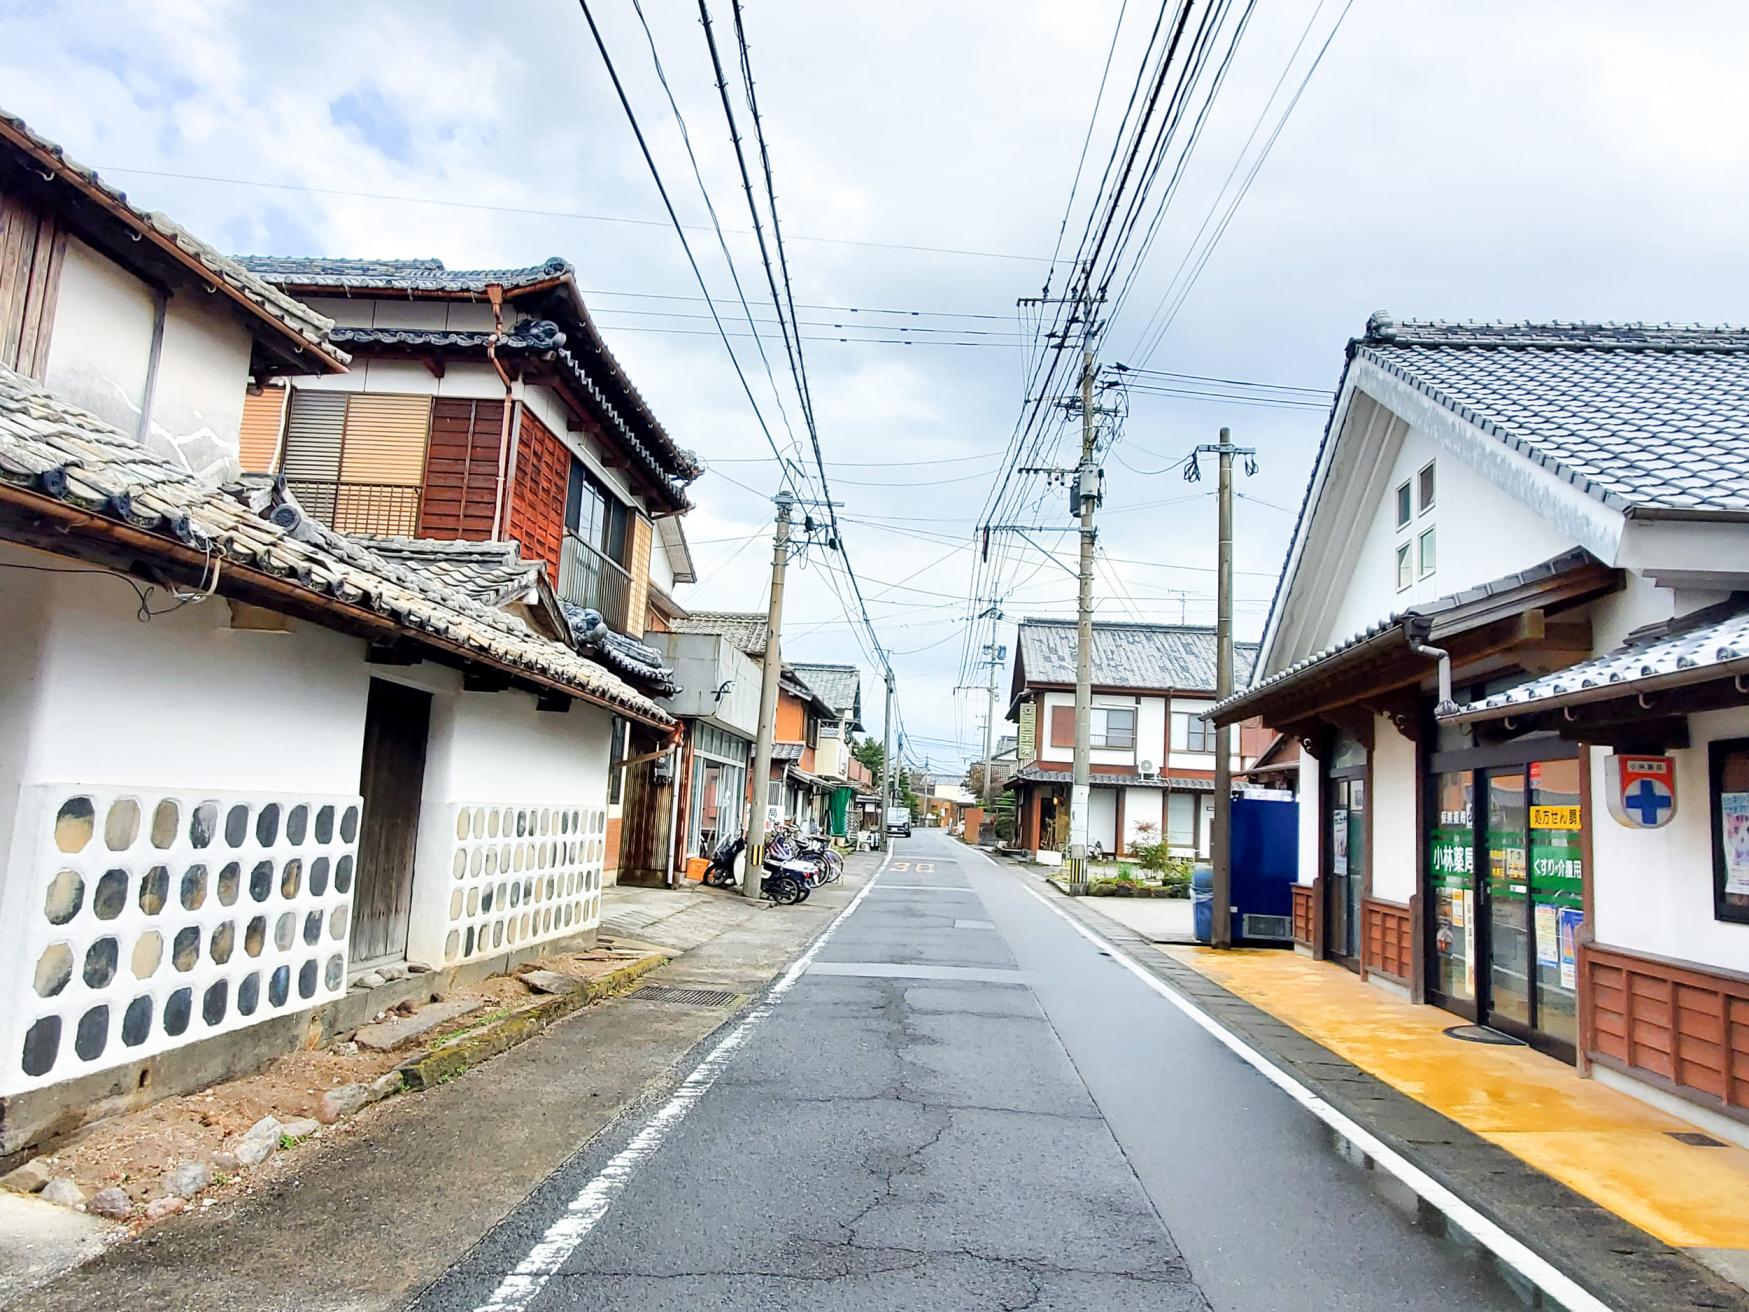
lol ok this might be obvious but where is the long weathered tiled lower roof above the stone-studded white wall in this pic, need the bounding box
[0,367,673,724]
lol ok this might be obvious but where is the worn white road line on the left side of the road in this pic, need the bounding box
[474,852,892,1312]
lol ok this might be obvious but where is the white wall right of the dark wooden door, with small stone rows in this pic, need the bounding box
[408,691,612,966]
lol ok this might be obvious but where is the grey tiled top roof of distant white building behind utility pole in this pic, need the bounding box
[1020,619,1258,693]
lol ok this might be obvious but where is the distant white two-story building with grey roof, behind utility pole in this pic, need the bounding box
[1004,619,1261,861]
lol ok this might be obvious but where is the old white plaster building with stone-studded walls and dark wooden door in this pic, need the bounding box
[0,115,673,1169]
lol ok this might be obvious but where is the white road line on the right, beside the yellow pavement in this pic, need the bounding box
[1021,885,1613,1312]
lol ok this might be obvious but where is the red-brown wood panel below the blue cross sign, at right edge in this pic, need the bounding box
[1579,945,1749,1111]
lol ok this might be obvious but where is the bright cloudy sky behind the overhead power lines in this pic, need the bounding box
[0,0,1749,771]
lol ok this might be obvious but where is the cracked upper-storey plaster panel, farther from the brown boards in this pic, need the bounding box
[145,290,252,483]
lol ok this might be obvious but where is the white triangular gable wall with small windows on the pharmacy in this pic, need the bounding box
[1313,427,1578,647]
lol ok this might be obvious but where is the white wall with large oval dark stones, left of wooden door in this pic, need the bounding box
[0,784,362,1095]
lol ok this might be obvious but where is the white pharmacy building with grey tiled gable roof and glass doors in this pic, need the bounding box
[1214,315,1749,1142]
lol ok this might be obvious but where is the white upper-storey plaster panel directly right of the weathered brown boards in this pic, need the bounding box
[42,238,155,434]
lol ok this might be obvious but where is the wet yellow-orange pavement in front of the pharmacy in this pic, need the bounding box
[1168,948,1749,1249]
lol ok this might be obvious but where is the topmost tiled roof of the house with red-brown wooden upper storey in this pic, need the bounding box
[240,255,703,485]
